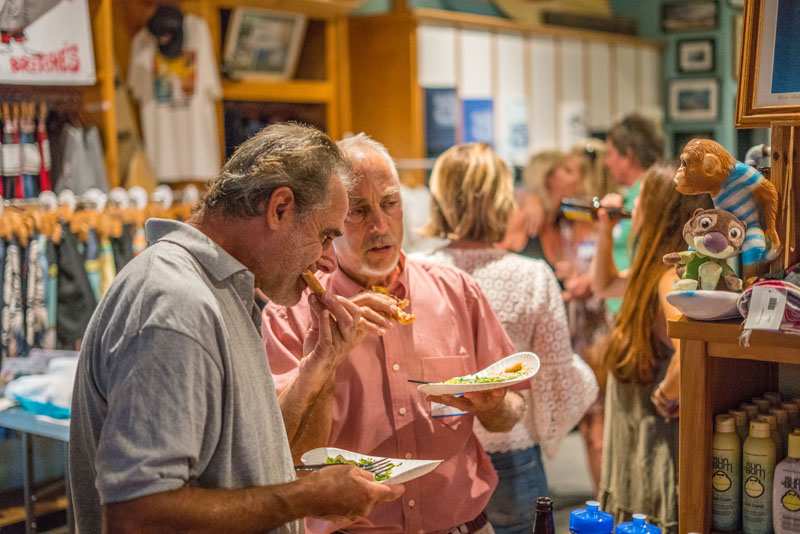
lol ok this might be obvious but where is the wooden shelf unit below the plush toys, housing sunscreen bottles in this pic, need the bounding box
[669,318,800,534]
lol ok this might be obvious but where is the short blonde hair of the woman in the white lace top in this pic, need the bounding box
[422,143,515,243]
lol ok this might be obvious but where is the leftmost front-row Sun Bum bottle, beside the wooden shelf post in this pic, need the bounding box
[711,414,742,532]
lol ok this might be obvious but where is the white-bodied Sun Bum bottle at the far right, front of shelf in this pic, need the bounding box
[772,430,800,534]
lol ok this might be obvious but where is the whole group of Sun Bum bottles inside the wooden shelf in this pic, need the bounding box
[711,393,800,534]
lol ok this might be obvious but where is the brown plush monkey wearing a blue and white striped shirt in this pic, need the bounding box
[675,139,781,277]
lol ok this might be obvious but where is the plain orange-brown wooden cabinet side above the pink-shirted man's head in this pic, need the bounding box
[348,16,424,162]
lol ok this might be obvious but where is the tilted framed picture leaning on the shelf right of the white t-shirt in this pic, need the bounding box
[224,7,306,81]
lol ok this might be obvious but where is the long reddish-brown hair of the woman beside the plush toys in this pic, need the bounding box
[604,164,713,384]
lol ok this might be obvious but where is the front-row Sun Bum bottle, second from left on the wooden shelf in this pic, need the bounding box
[742,421,775,534]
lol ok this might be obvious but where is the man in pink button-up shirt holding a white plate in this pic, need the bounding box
[264,135,525,533]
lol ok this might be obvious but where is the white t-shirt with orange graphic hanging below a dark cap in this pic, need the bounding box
[128,14,222,182]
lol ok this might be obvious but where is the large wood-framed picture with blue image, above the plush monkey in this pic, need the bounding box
[736,0,800,128]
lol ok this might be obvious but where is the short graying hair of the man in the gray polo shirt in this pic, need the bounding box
[200,123,349,217]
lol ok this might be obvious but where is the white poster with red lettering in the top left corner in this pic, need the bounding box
[0,0,95,85]
